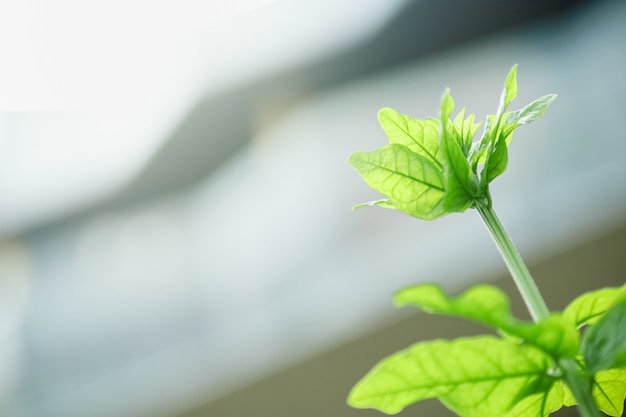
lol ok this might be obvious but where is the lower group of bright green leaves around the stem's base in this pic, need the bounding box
[348,284,626,417]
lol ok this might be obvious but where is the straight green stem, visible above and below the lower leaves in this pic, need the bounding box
[475,202,600,417]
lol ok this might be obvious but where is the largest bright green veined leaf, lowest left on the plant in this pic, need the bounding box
[348,336,553,417]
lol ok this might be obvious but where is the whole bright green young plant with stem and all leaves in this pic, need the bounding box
[348,66,626,417]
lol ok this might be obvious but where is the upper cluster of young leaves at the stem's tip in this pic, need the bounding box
[349,65,556,220]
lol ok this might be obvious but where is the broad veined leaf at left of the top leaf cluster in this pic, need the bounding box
[349,144,446,220]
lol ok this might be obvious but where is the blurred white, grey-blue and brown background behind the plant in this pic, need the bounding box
[0,0,626,417]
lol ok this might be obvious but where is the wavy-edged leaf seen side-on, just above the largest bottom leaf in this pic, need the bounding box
[394,284,579,358]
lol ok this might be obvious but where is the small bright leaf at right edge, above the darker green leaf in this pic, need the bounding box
[563,285,626,327]
